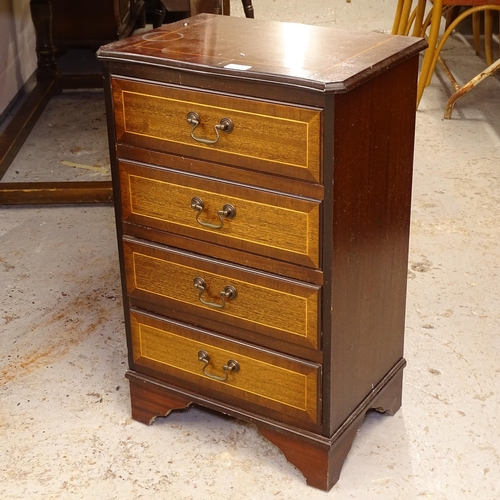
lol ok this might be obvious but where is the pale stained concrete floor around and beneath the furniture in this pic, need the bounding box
[0,0,500,500]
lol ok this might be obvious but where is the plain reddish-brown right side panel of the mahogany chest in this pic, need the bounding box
[324,57,418,428]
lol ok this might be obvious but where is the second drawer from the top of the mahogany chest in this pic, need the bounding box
[119,162,320,268]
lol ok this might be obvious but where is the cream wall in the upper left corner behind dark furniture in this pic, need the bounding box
[0,0,36,114]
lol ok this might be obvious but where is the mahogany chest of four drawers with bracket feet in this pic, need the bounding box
[99,14,425,490]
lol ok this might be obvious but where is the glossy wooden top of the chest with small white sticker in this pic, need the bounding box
[98,14,426,92]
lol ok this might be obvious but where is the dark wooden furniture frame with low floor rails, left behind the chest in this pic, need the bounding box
[0,0,144,204]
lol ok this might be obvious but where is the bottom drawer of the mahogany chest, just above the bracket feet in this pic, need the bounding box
[130,311,321,424]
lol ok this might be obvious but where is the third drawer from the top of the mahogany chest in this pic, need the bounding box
[123,239,320,349]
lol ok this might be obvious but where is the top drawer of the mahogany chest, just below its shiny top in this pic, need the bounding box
[112,78,322,182]
